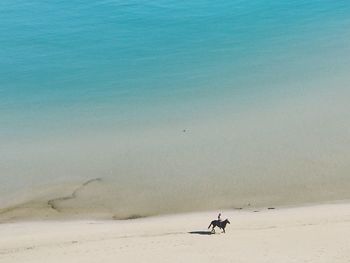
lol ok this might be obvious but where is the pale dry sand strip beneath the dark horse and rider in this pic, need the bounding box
[0,204,350,263]
